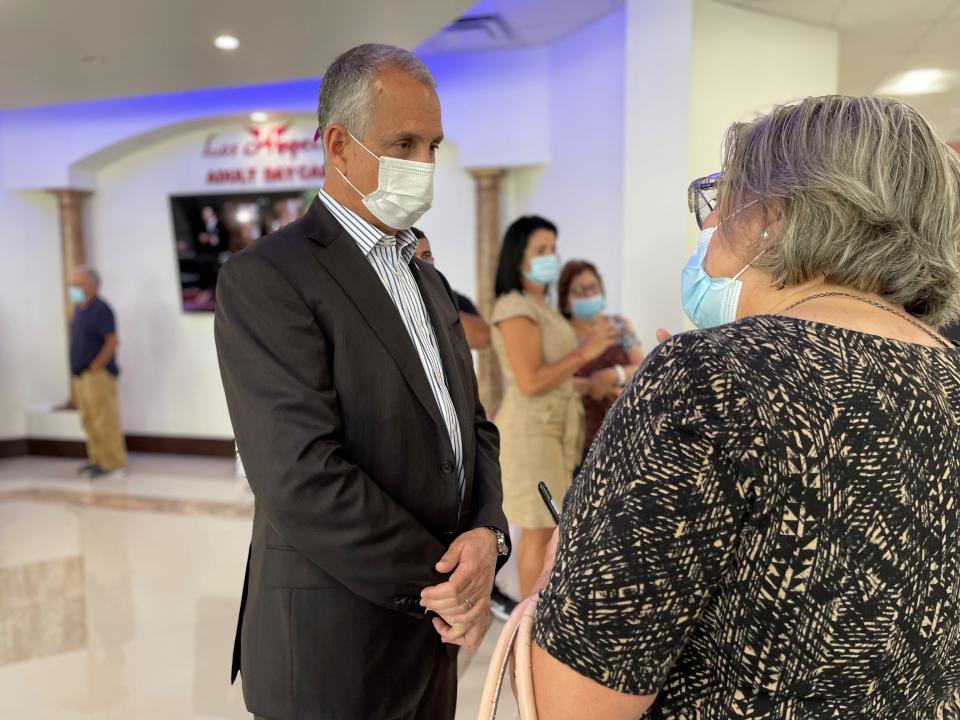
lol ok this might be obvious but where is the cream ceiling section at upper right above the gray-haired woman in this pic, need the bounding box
[720,0,960,140]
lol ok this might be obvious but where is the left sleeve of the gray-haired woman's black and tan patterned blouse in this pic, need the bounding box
[534,333,751,695]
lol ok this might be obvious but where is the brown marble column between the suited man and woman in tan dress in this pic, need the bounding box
[469,168,504,417]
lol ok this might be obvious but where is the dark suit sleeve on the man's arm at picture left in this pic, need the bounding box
[214,253,445,617]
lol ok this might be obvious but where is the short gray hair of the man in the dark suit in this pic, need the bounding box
[317,43,437,138]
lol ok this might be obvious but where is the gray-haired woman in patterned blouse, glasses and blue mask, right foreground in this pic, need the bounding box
[533,96,960,720]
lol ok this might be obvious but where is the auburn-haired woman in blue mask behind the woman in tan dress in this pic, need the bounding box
[558,260,643,452]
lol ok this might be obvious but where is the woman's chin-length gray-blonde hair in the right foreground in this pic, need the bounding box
[720,95,960,326]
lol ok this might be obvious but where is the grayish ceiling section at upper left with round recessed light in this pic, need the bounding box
[0,0,474,109]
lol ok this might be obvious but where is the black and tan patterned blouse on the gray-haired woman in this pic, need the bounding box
[535,316,960,720]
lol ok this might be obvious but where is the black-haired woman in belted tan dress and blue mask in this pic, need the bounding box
[491,216,617,597]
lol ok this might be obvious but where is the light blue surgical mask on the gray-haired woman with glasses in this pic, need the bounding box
[680,227,756,328]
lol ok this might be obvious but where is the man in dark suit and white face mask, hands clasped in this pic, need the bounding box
[216,45,509,720]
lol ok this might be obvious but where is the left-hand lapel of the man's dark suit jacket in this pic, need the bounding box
[304,200,446,444]
